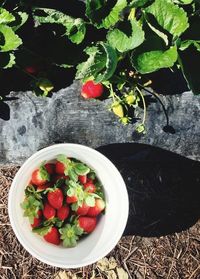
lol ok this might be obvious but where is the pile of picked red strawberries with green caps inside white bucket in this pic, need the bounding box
[21,155,105,247]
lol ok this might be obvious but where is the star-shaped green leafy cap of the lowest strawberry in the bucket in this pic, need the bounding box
[59,224,83,247]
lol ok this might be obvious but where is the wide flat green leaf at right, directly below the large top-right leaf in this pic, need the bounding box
[132,46,178,74]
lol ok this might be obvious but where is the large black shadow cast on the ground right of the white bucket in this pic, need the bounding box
[97,143,200,236]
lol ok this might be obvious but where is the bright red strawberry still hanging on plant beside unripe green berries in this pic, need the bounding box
[81,80,104,99]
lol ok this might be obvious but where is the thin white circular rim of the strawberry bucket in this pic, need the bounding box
[8,143,129,268]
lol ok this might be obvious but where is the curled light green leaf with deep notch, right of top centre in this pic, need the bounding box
[107,20,144,52]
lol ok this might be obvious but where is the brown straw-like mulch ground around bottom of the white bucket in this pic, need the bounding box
[0,167,200,279]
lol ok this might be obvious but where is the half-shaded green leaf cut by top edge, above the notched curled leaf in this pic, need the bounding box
[86,0,127,29]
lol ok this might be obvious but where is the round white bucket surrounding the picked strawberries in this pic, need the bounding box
[8,144,129,268]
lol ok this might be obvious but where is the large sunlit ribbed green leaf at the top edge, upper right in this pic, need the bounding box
[145,0,189,37]
